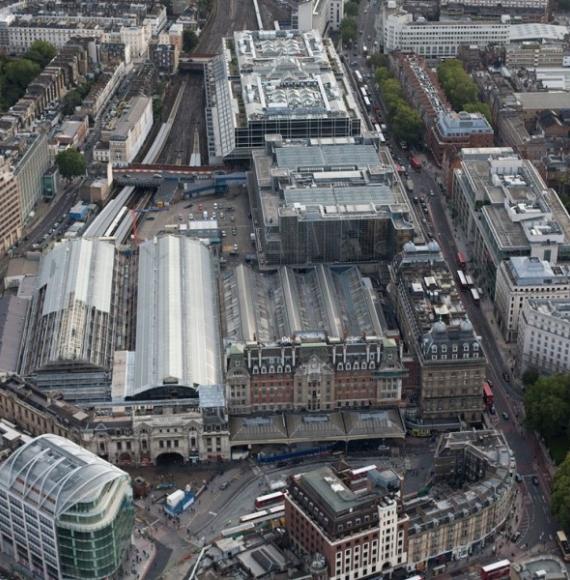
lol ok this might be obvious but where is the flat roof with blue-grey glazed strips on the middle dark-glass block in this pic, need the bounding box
[253,138,412,227]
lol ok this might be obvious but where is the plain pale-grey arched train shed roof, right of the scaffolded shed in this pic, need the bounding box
[131,235,222,396]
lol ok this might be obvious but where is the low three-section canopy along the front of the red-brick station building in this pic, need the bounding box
[230,408,406,445]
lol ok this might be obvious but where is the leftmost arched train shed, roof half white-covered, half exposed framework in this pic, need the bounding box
[20,238,128,402]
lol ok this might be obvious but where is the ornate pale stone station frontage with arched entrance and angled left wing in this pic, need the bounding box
[0,375,230,465]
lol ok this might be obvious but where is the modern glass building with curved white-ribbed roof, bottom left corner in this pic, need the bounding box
[0,435,134,580]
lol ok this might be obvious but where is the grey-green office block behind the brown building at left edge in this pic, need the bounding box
[0,132,50,223]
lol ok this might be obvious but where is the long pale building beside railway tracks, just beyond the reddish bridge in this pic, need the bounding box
[101,96,153,166]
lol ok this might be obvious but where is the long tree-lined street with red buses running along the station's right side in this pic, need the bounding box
[344,0,558,568]
